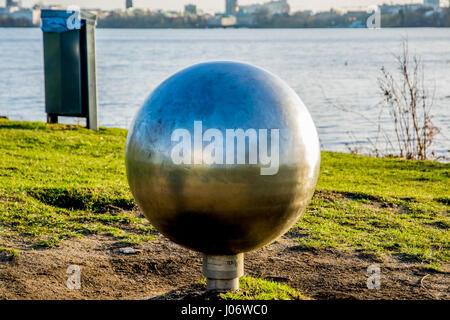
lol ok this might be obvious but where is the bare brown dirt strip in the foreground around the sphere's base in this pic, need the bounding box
[0,235,450,299]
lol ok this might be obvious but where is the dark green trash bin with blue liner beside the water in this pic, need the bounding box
[41,10,98,130]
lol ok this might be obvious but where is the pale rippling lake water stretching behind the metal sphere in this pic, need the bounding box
[0,28,450,155]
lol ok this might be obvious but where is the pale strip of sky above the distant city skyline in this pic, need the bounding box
[5,0,438,13]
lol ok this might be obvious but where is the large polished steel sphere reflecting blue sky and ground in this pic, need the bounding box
[125,62,320,255]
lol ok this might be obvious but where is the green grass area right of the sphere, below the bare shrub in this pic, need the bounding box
[290,152,450,269]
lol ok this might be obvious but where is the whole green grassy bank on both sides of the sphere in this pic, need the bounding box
[0,120,450,276]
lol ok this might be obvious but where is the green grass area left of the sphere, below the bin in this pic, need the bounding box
[0,120,156,248]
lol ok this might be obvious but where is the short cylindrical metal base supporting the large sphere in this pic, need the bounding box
[203,253,244,292]
